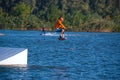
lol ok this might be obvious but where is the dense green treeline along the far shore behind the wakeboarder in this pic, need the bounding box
[0,0,120,32]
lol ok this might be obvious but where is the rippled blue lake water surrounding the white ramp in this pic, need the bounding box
[0,30,120,80]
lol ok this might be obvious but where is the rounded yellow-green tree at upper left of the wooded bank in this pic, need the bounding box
[12,2,31,28]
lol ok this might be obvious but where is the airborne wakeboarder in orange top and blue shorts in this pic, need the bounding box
[54,17,66,38]
